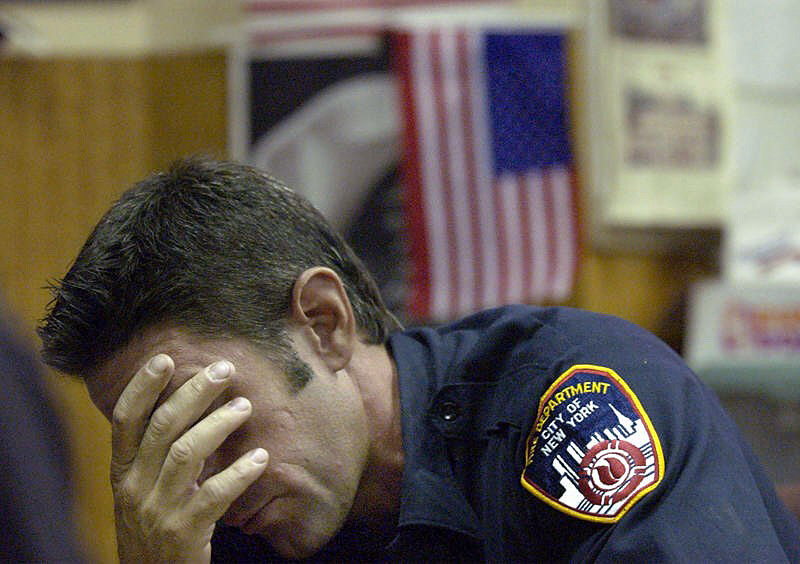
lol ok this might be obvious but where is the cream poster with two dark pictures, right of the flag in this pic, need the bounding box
[589,0,732,228]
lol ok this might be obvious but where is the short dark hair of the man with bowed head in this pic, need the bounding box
[38,157,399,377]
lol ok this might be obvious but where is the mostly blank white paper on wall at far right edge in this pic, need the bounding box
[722,0,800,286]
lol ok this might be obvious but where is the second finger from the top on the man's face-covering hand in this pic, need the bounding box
[134,360,234,483]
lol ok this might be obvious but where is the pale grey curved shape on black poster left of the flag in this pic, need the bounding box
[249,73,400,229]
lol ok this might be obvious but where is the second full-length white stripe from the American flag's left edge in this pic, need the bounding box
[441,29,475,317]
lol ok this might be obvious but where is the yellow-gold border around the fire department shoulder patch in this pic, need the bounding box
[520,364,665,523]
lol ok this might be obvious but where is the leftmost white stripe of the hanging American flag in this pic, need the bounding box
[411,33,450,318]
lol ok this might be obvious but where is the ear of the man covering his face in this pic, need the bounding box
[292,266,356,372]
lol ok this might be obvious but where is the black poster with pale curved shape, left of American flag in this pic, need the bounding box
[229,8,407,318]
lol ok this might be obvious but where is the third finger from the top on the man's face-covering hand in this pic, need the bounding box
[156,398,252,503]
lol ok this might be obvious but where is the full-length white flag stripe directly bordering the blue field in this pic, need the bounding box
[462,32,500,309]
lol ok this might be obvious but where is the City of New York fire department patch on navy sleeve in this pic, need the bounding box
[522,364,664,523]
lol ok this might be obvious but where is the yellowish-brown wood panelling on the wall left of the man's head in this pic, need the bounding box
[0,53,226,562]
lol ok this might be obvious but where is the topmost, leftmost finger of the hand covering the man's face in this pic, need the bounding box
[111,354,175,481]
